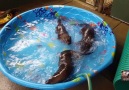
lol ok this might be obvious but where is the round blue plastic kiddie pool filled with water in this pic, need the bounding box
[0,5,116,90]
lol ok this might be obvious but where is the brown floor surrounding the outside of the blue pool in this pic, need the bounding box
[0,0,129,90]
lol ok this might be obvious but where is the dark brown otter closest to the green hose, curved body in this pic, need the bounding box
[46,50,76,84]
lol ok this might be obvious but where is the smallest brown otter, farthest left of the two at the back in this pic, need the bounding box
[56,19,71,44]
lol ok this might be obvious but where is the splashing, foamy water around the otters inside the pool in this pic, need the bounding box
[2,18,108,84]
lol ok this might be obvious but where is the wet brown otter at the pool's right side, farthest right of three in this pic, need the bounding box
[80,24,95,54]
